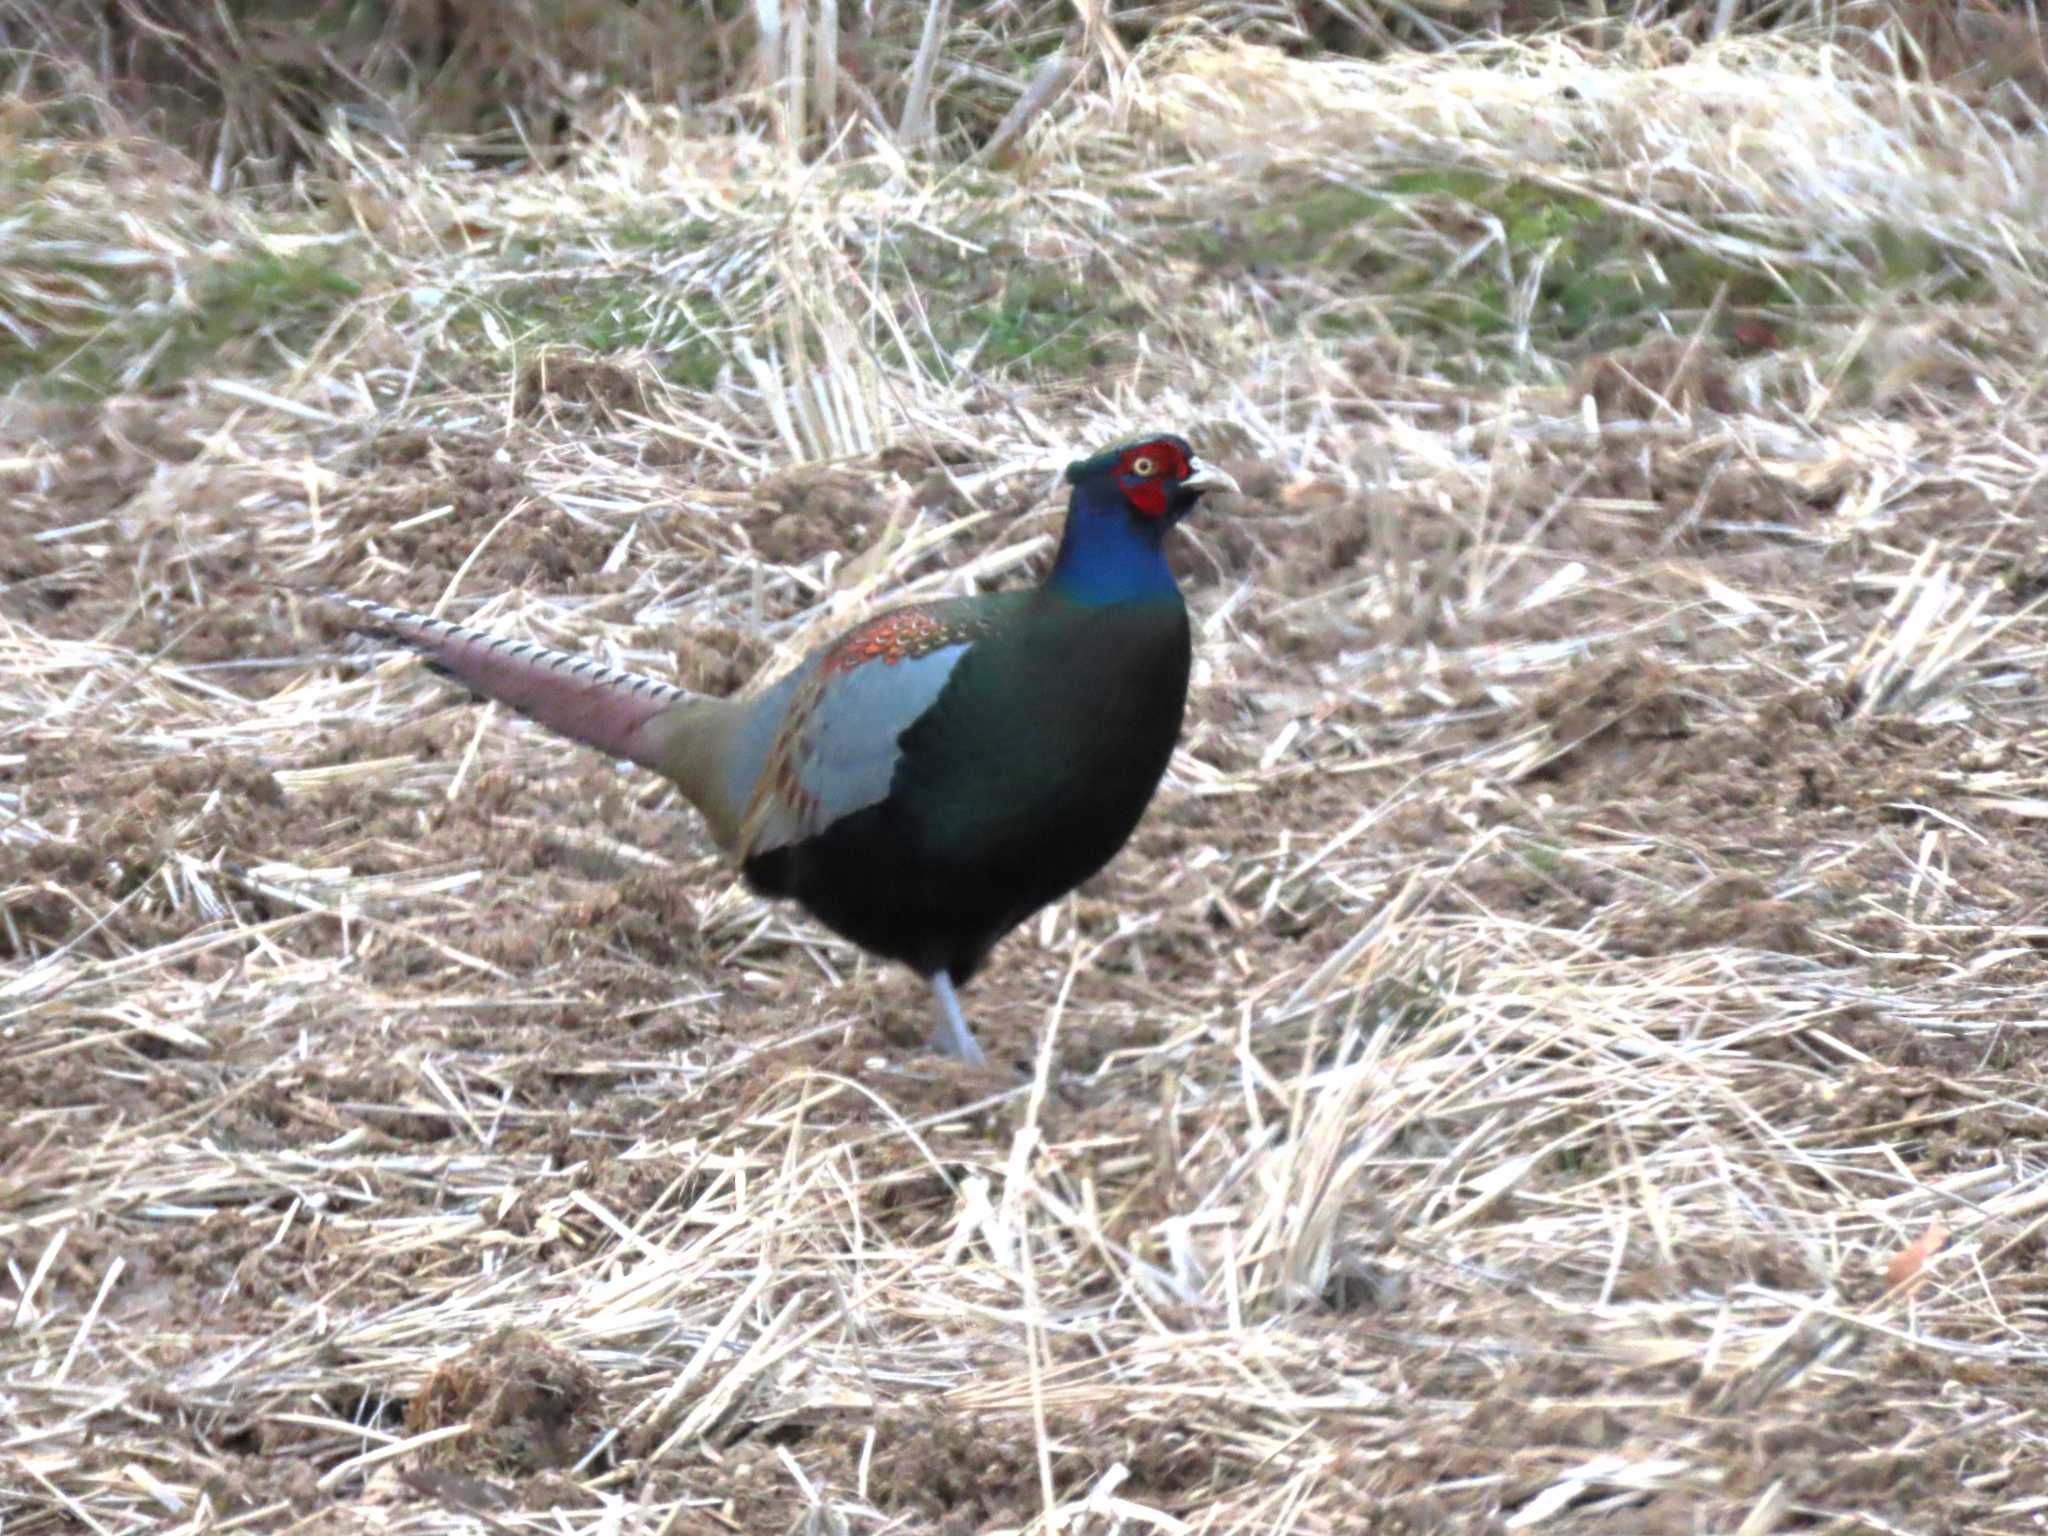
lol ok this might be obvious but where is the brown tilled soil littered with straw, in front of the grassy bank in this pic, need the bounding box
[0,30,2048,1536]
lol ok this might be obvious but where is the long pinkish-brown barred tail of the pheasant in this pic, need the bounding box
[324,592,694,770]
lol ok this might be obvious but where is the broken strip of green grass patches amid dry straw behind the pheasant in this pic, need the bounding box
[0,168,1985,397]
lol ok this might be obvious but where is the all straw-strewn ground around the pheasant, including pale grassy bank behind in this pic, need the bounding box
[0,8,2048,1536]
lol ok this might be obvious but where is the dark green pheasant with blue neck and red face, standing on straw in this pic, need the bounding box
[336,434,1237,1063]
